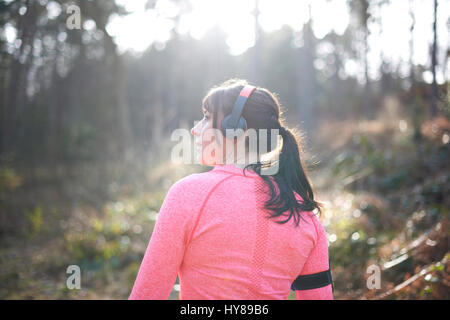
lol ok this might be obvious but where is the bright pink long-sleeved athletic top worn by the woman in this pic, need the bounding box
[129,164,333,300]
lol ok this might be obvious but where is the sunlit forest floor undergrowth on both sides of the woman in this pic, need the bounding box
[0,111,450,299]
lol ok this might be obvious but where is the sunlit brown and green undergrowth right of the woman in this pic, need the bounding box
[313,114,450,299]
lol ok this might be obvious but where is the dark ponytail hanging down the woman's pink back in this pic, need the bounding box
[244,126,322,226]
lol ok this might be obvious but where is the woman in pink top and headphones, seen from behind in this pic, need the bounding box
[129,79,333,300]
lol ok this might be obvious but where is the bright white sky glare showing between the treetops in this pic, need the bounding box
[106,0,450,77]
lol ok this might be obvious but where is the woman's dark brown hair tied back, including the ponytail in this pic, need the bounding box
[202,78,321,226]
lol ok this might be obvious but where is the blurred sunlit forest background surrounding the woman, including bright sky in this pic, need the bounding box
[0,0,450,299]
